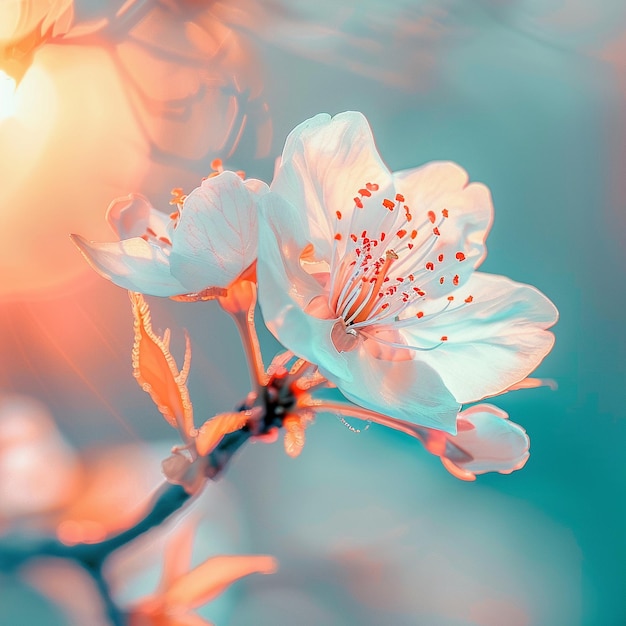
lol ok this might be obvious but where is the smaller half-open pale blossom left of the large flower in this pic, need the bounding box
[72,171,268,299]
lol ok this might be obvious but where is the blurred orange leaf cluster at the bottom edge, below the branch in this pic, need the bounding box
[128,530,277,626]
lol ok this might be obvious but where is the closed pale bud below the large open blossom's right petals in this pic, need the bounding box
[441,404,530,480]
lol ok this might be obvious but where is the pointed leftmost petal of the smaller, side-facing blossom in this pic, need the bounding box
[71,235,189,296]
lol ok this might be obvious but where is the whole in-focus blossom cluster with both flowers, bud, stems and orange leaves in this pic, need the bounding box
[73,112,558,482]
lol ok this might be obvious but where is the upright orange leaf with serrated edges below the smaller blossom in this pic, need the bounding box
[128,291,193,438]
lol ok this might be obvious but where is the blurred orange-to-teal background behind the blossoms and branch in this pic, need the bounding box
[0,0,626,626]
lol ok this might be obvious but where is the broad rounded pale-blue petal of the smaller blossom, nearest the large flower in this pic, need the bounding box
[170,172,267,292]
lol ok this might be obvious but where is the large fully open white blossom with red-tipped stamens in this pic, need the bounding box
[258,112,558,432]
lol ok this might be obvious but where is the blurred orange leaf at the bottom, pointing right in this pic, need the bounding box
[163,555,277,608]
